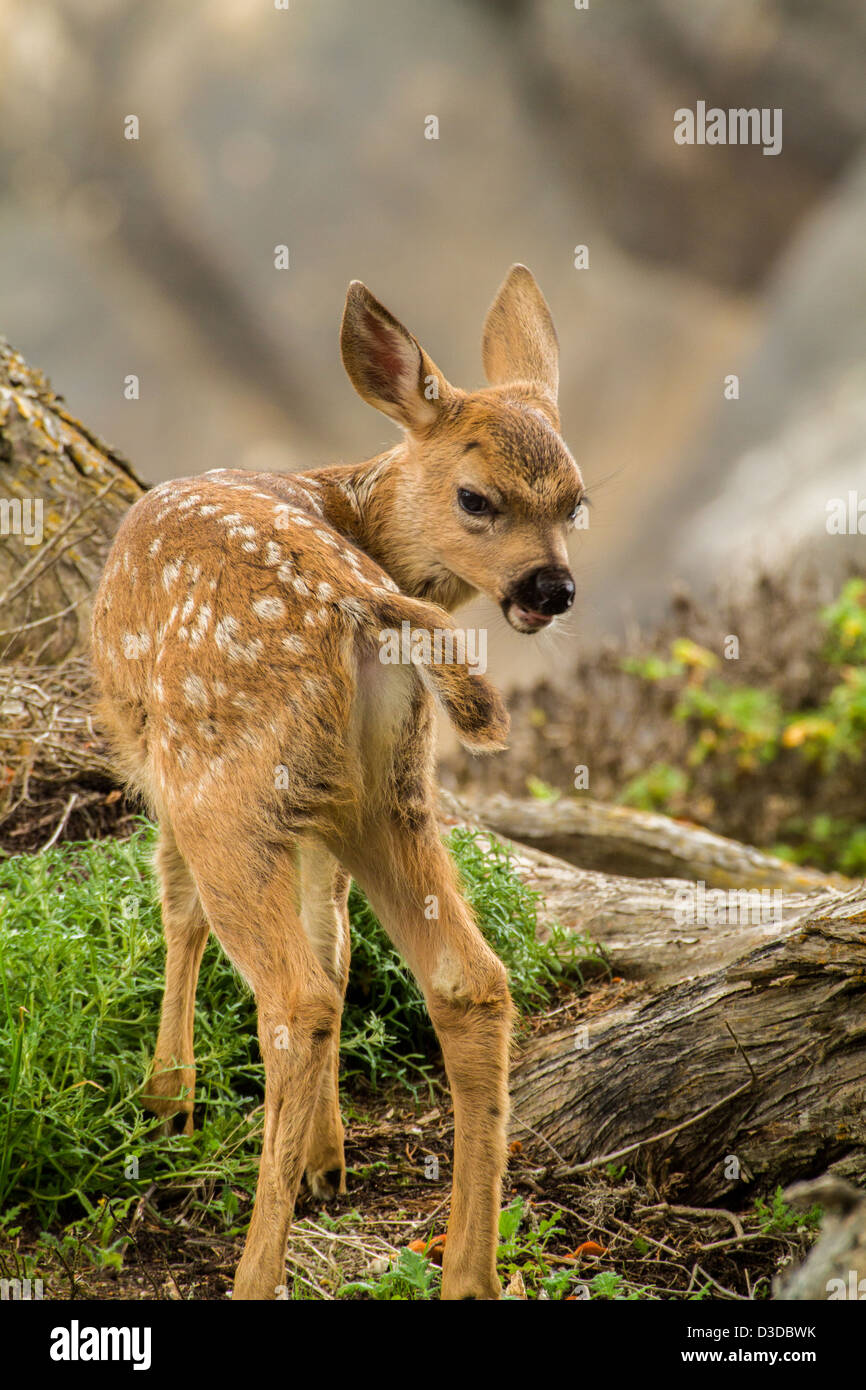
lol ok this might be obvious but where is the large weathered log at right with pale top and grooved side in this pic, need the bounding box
[441,794,866,1207]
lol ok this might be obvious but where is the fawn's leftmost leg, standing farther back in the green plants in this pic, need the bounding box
[142,819,210,1134]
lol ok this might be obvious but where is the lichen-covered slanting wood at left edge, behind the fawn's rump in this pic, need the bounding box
[0,338,145,664]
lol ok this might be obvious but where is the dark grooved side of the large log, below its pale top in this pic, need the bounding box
[512,885,866,1202]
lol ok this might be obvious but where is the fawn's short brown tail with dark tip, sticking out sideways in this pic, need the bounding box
[364,594,510,753]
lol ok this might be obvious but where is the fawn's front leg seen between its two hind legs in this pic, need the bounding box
[300,841,350,1201]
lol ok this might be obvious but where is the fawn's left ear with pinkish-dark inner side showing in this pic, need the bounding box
[339,279,452,434]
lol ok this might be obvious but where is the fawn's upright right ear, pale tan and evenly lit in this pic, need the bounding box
[481,265,559,406]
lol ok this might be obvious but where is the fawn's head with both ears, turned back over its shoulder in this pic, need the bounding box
[341,265,584,632]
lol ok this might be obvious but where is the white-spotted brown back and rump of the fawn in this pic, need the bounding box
[93,470,500,835]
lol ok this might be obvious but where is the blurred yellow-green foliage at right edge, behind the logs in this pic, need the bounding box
[620,580,866,876]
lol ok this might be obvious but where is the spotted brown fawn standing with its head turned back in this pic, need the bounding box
[93,265,584,1298]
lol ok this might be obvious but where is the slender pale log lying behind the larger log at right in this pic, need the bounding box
[458,794,845,892]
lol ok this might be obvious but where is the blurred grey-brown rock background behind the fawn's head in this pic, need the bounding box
[0,0,866,685]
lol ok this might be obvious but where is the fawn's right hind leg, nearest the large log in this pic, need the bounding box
[340,816,513,1298]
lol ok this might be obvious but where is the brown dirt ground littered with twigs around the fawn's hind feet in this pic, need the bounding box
[0,983,815,1300]
